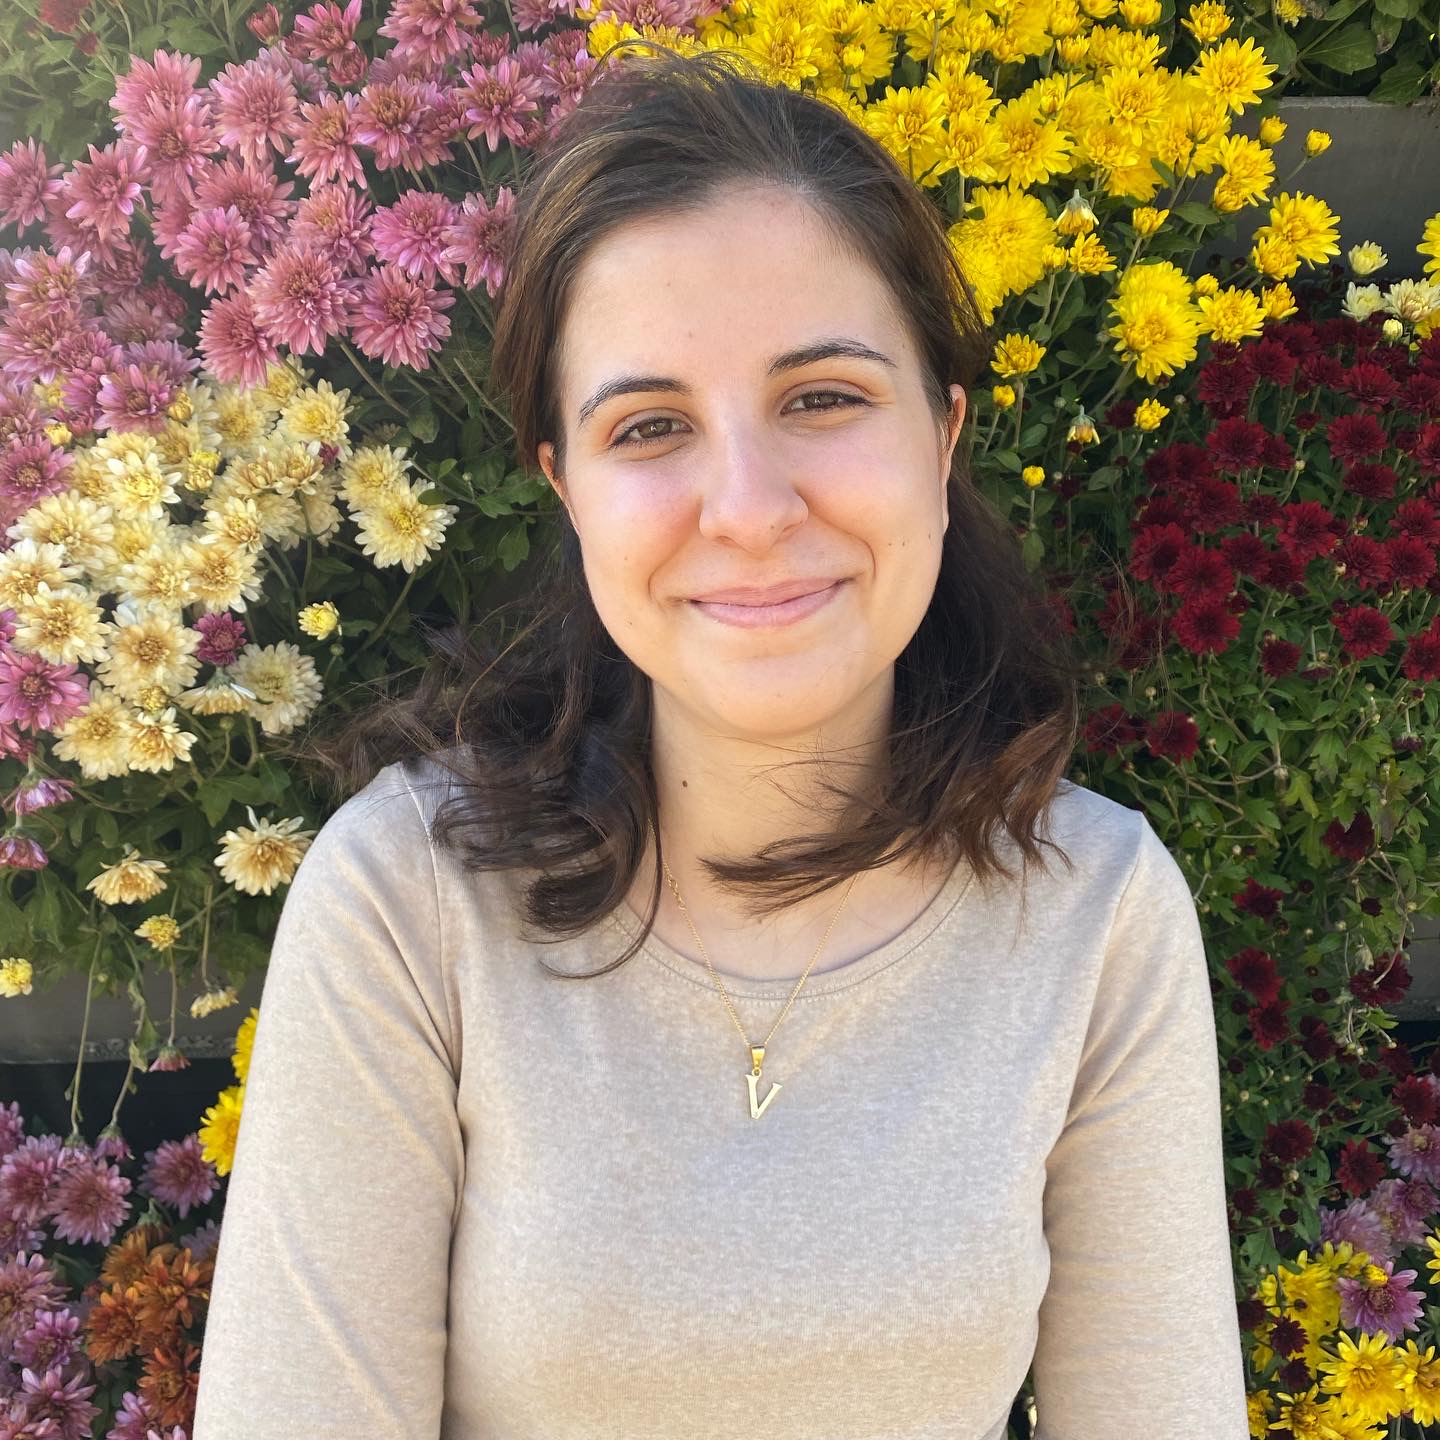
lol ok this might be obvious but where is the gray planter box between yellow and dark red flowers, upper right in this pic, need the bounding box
[1195,95,1440,284]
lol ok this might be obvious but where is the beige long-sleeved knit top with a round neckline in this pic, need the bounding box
[192,762,1248,1440]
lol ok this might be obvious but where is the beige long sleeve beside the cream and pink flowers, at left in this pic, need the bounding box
[193,766,464,1440]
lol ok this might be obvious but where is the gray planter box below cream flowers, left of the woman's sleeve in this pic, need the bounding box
[0,971,265,1064]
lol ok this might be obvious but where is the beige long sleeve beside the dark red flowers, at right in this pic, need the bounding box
[1034,816,1248,1440]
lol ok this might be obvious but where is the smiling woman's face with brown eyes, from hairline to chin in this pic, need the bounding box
[539,186,965,742]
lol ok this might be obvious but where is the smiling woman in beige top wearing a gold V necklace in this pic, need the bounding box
[196,42,1247,1440]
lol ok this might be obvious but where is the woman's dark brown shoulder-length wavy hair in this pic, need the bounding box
[300,42,1081,979]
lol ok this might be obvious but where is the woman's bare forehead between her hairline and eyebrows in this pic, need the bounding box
[560,186,906,377]
